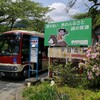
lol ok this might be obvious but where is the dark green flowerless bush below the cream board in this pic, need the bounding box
[54,62,80,87]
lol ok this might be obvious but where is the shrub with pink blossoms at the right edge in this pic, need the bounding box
[84,43,100,86]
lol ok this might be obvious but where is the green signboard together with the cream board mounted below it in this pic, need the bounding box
[44,18,92,78]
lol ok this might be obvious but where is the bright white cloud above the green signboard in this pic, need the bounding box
[47,3,80,22]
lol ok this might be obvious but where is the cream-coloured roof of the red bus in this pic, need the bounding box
[4,30,44,38]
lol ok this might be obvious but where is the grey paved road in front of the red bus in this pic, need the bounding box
[0,73,47,100]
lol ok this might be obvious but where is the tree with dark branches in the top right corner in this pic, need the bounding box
[69,0,100,29]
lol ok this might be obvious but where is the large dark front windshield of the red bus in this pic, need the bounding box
[0,33,21,56]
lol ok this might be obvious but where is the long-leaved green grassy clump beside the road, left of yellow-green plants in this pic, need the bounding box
[23,83,68,100]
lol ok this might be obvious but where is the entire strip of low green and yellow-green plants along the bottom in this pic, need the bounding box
[23,82,100,100]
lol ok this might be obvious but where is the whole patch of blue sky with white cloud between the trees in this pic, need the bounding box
[33,0,92,22]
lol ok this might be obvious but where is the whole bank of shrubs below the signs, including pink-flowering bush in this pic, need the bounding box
[53,43,100,89]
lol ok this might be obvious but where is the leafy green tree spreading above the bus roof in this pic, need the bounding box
[0,0,51,30]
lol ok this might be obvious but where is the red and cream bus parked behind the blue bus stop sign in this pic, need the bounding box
[0,30,48,78]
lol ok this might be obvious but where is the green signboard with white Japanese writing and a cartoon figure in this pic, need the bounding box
[44,18,92,46]
